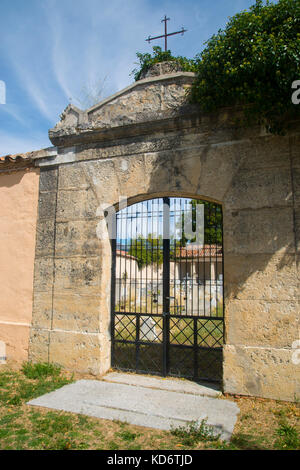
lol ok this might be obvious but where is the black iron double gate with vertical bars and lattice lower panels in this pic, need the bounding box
[111,197,224,381]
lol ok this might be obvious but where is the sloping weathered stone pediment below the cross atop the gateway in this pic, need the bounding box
[49,64,194,145]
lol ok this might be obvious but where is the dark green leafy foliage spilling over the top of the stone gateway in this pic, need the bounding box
[135,0,300,134]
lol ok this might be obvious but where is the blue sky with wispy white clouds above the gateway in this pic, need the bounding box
[0,0,255,155]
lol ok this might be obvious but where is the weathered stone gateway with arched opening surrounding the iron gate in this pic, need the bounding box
[0,64,300,401]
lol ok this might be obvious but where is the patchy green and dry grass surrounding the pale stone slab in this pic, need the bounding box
[0,364,300,450]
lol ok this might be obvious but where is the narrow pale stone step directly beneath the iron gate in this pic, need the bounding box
[103,372,222,398]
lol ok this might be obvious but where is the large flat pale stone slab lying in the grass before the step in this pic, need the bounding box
[28,380,239,440]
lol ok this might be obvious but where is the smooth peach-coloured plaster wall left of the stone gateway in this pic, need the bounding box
[0,169,39,362]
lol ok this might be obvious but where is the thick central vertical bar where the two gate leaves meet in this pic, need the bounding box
[163,197,170,376]
